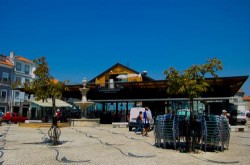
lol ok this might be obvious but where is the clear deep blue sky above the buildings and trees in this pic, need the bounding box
[0,0,250,95]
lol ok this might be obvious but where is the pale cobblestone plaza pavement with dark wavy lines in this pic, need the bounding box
[0,124,250,165]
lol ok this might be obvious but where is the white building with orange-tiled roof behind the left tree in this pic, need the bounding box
[9,52,36,116]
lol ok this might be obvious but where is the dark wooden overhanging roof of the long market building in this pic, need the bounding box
[64,76,248,100]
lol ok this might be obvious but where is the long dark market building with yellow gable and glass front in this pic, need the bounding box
[63,63,248,123]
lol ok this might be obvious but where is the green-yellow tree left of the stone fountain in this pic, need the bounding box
[23,57,68,114]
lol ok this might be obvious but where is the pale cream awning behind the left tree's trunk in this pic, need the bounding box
[30,98,72,107]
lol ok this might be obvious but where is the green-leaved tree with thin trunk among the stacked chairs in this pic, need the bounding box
[164,58,222,151]
